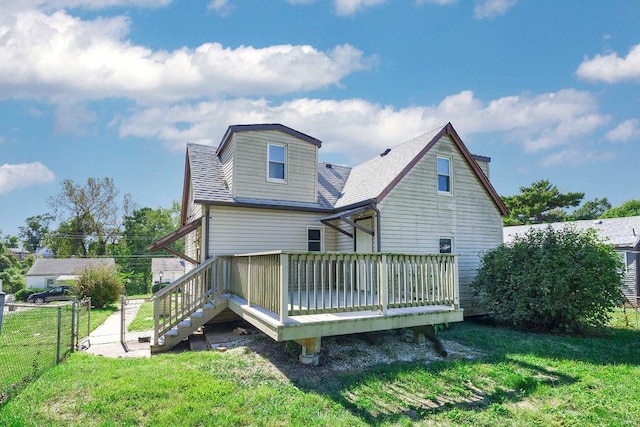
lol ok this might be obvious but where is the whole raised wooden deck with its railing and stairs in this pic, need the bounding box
[154,251,463,356]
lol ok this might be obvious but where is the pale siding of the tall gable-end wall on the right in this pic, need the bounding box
[379,136,502,314]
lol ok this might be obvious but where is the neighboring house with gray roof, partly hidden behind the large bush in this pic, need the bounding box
[504,216,640,304]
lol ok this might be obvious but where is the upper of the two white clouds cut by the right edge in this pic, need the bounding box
[576,44,640,83]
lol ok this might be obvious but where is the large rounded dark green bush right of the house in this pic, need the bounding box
[472,227,624,332]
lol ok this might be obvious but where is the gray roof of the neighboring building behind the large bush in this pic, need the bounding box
[502,216,640,248]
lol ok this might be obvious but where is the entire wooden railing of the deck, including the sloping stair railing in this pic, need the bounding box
[153,251,459,344]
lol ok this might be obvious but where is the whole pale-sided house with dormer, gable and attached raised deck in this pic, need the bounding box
[149,124,507,362]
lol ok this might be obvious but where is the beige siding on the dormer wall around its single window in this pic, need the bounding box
[233,131,318,202]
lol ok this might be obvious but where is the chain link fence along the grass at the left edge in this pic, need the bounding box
[0,296,91,403]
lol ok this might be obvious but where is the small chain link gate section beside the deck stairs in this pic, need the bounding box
[120,296,153,352]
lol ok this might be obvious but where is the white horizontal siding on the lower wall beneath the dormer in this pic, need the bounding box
[209,206,337,256]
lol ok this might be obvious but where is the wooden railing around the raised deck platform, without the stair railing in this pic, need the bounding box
[222,251,459,322]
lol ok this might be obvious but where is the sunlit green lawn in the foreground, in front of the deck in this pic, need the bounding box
[0,312,640,426]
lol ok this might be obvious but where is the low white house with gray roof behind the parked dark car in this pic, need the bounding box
[26,258,116,288]
